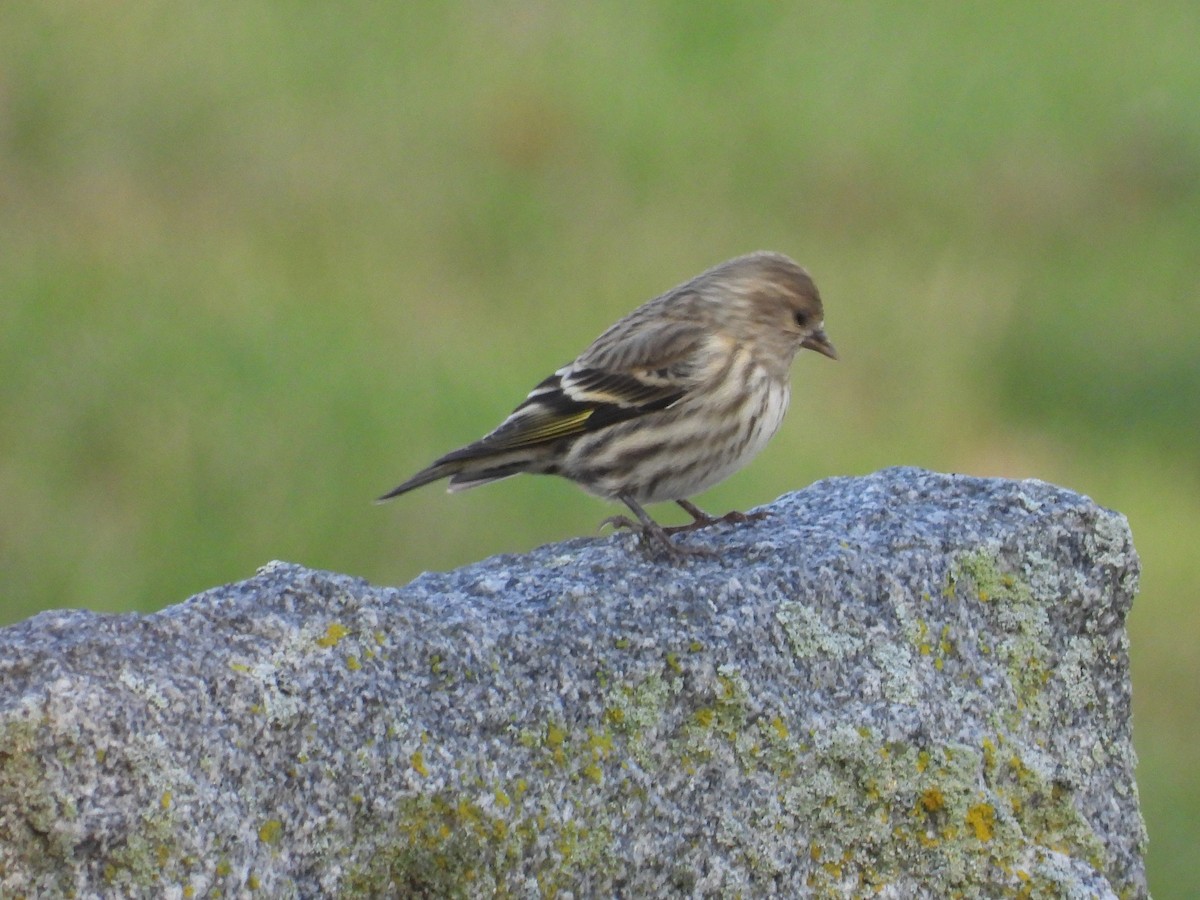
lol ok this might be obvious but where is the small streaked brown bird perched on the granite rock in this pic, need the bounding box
[379,252,838,556]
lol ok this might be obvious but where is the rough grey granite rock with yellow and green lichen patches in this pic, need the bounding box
[0,469,1146,898]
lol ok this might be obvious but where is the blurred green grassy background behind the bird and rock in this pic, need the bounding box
[0,0,1200,899]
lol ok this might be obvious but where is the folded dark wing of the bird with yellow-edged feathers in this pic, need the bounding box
[439,322,706,462]
